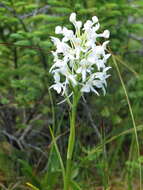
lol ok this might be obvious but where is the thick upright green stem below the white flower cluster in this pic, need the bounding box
[64,92,79,190]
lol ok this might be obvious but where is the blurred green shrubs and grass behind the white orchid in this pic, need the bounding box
[0,0,143,190]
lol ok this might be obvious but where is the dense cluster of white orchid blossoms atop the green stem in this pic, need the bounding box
[50,13,111,95]
